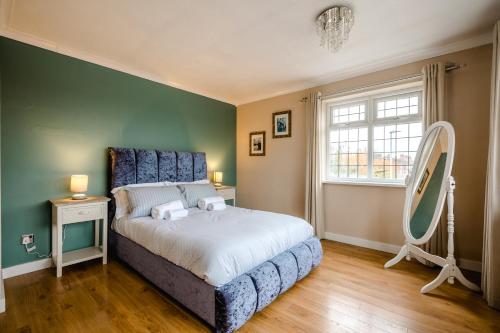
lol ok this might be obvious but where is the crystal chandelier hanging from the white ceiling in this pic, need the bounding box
[316,6,354,52]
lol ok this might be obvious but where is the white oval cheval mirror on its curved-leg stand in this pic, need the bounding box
[384,121,479,293]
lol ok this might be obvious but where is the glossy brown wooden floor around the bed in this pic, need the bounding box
[0,241,500,333]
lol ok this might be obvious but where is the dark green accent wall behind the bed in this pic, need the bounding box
[0,37,236,267]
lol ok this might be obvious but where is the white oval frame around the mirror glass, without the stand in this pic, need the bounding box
[403,121,455,245]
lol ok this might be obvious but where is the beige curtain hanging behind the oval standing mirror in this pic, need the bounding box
[422,63,448,256]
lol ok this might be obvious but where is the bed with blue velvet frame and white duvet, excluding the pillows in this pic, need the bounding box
[109,148,322,332]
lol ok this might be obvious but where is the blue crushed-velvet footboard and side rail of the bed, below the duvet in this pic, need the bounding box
[109,230,323,333]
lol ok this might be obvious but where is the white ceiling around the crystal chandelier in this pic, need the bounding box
[0,0,500,105]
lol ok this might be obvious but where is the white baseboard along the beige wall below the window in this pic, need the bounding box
[325,232,482,273]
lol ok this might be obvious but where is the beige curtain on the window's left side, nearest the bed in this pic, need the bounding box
[305,92,325,239]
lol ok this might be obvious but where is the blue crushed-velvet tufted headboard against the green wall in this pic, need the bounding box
[109,148,207,190]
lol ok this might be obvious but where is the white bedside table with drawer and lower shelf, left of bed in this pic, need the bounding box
[50,197,110,277]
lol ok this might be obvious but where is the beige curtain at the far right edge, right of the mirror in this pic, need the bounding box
[482,21,500,309]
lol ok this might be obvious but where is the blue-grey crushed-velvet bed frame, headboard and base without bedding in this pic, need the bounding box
[109,148,322,332]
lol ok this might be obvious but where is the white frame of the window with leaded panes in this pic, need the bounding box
[322,81,423,187]
